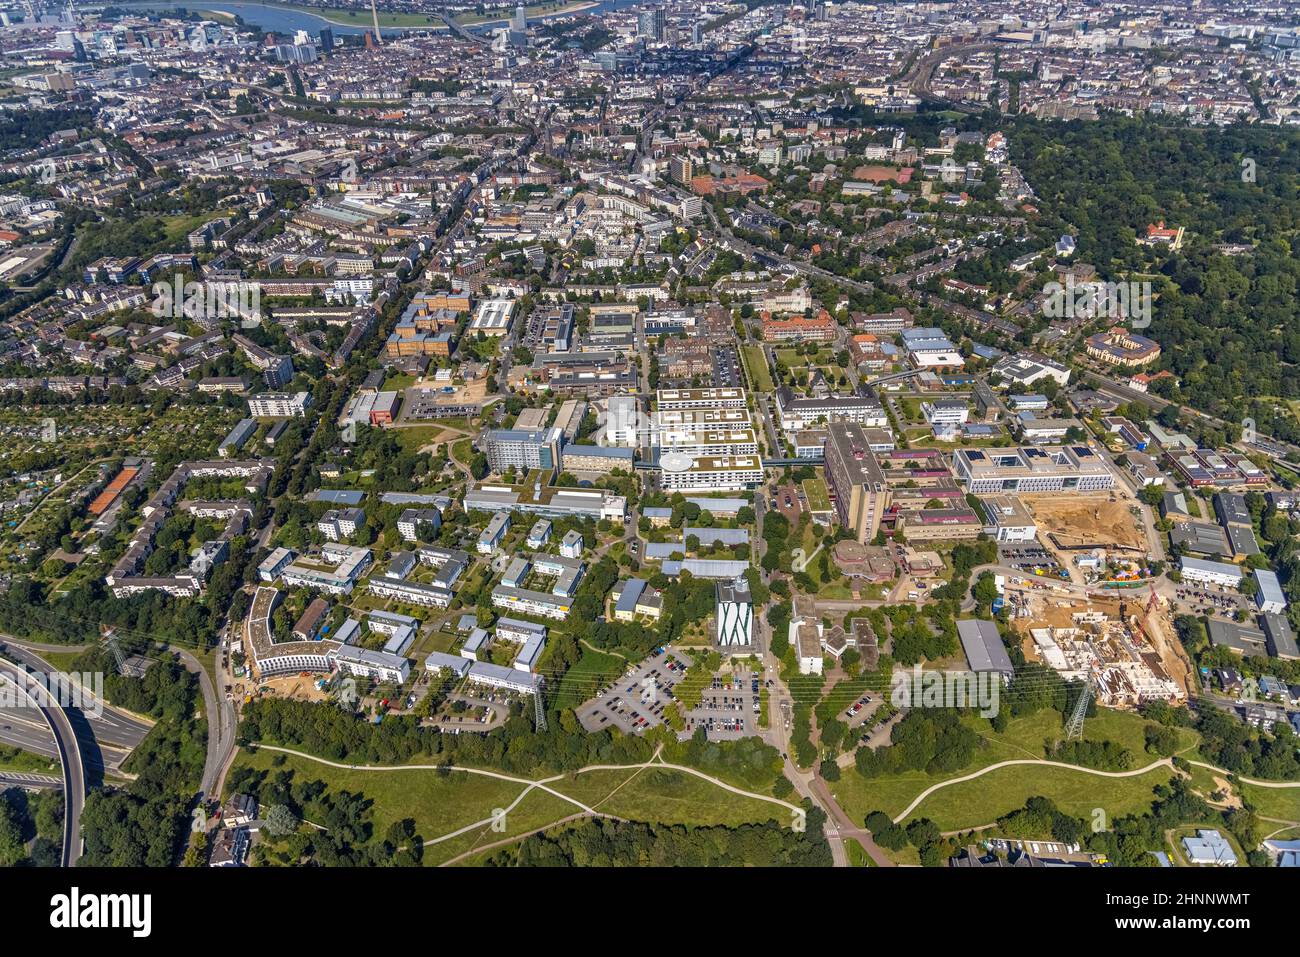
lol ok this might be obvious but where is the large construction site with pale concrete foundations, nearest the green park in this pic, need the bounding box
[1004,579,1192,709]
